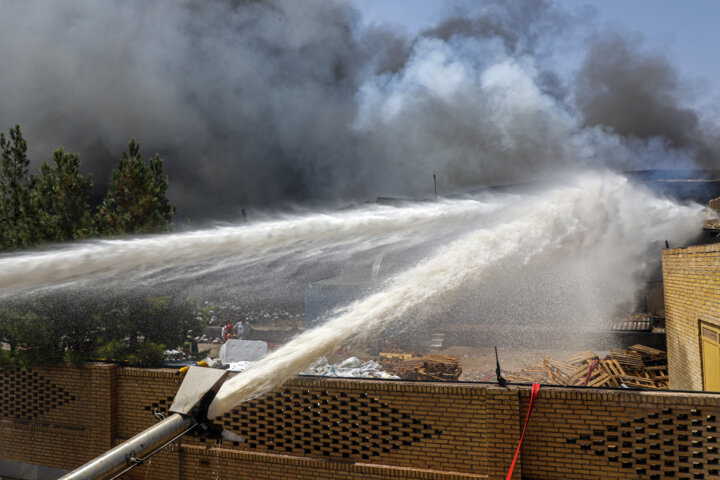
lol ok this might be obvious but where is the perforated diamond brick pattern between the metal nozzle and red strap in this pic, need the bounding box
[217,389,441,461]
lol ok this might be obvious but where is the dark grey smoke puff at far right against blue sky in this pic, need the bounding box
[575,30,720,168]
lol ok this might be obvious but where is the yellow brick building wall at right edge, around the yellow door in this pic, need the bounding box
[662,244,720,390]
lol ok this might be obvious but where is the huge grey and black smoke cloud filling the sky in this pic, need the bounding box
[0,0,720,218]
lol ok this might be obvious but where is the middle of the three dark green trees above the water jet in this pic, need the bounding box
[32,147,97,242]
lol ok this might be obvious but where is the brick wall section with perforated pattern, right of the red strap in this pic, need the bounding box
[520,388,720,480]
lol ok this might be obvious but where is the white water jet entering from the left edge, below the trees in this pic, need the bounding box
[0,200,497,295]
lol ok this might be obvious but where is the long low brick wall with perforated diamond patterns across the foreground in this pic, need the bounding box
[0,365,720,480]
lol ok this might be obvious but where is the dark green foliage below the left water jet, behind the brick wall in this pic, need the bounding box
[0,290,204,366]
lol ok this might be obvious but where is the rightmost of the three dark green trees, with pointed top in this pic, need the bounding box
[97,138,176,235]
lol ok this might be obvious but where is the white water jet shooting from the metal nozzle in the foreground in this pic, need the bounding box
[204,174,702,418]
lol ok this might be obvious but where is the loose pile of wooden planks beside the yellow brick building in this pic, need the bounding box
[505,345,668,389]
